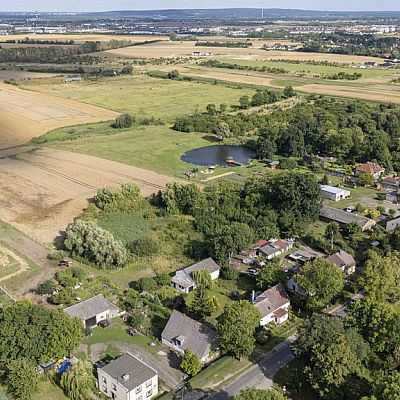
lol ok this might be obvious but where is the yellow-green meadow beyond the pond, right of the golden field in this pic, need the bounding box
[23,75,254,122]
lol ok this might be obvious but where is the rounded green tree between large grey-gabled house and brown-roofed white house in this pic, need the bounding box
[216,300,260,359]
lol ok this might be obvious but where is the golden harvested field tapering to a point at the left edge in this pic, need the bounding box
[0,84,117,149]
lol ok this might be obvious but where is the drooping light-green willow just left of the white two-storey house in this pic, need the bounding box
[60,360,95,400]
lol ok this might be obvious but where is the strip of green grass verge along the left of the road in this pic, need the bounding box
[189,356,252,389]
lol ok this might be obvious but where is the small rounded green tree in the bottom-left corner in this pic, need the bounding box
[6,358,39,400]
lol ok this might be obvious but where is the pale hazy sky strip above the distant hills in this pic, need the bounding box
[0,0,400,11]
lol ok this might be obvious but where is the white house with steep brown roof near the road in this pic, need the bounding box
[252,283,290,326]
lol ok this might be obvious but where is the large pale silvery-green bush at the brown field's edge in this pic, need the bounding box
[64,220,128,268]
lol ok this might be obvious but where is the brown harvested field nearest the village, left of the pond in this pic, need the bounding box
[0,147,183,242]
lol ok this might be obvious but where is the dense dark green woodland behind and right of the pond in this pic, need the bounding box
[174,97,400,171]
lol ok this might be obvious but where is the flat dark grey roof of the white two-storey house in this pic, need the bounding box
[99,352,157,391]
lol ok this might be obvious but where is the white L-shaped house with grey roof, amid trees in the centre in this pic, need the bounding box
[171,257,220,293]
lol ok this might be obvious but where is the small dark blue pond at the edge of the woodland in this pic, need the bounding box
[181,145,256,167]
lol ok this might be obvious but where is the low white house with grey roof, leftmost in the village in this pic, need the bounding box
[64,294,120,328]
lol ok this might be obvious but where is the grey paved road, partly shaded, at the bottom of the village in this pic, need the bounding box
[207,336,295,400]
